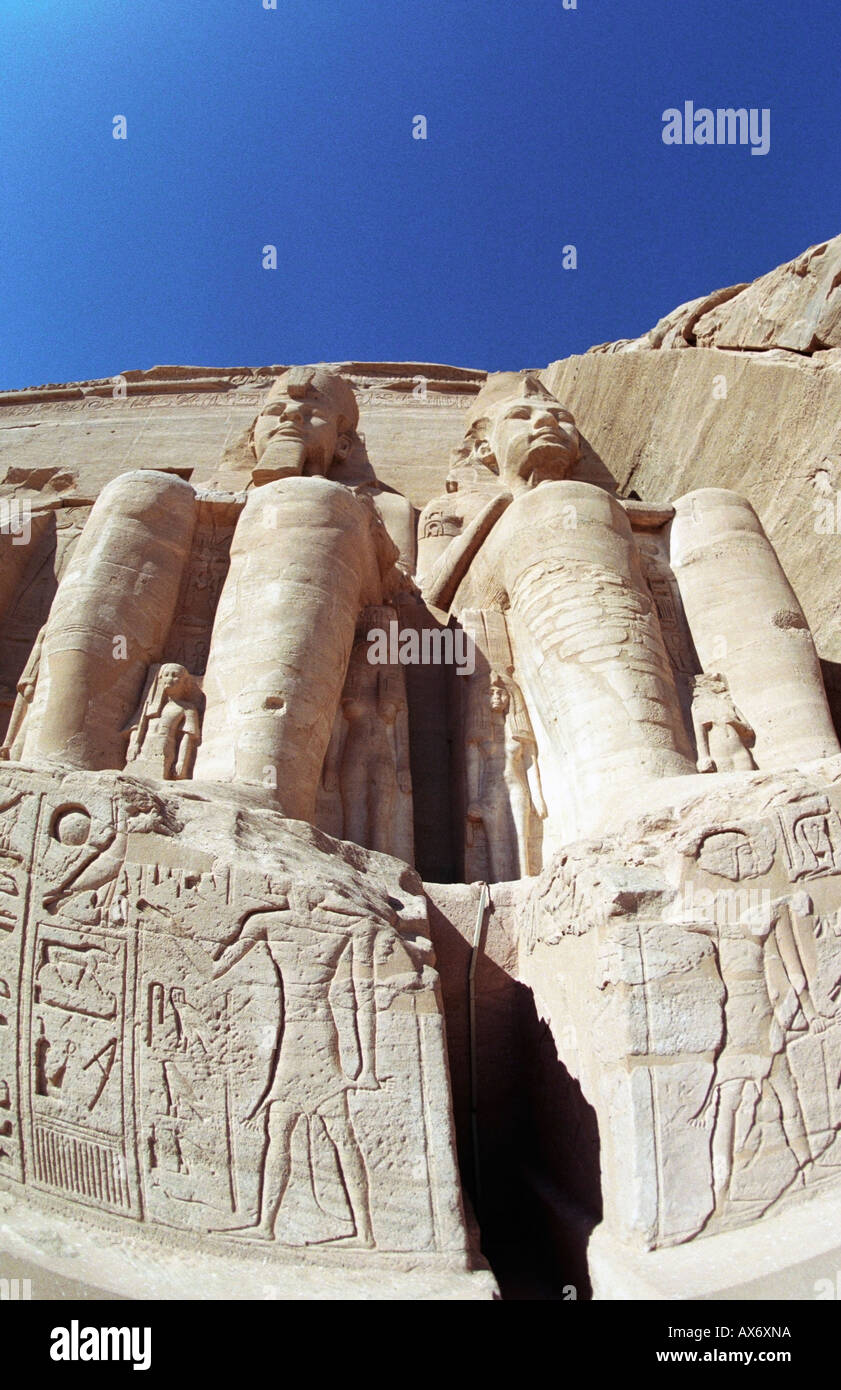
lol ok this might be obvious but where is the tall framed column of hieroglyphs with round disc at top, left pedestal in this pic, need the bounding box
[19,795,143,1219]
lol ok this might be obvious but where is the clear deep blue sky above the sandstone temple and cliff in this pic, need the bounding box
[0,0,841,388]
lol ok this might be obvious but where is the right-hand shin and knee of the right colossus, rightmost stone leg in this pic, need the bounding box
[671,488,840,767]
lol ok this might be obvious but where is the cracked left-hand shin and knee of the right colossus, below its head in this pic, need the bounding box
[474,480,695,833]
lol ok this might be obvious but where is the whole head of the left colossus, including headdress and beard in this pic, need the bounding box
[253,367,359,482]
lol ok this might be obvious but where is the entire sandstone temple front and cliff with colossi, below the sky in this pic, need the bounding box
[0,243,841,1298]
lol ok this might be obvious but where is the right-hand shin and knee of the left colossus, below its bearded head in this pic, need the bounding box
[195,478,398,821]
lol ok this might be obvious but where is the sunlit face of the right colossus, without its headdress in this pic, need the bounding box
[488,396,578,491]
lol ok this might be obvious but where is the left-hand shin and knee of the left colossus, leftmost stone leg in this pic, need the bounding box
[24,470,196,770]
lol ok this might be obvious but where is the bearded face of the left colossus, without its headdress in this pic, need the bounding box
[254,388,339,477]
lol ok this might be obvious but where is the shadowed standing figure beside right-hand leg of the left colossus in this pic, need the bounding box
[322,605,414,863]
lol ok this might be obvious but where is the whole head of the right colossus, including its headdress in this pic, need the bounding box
[448,371,580,492]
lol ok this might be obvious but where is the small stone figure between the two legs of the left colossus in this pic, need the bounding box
[124,662,202,781]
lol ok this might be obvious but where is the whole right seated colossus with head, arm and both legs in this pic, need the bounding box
[418,374,838,845]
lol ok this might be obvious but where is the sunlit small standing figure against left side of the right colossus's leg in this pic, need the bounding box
[466,671,546,883]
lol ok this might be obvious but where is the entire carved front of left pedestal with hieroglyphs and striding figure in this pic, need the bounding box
[0,773,464,1267]
